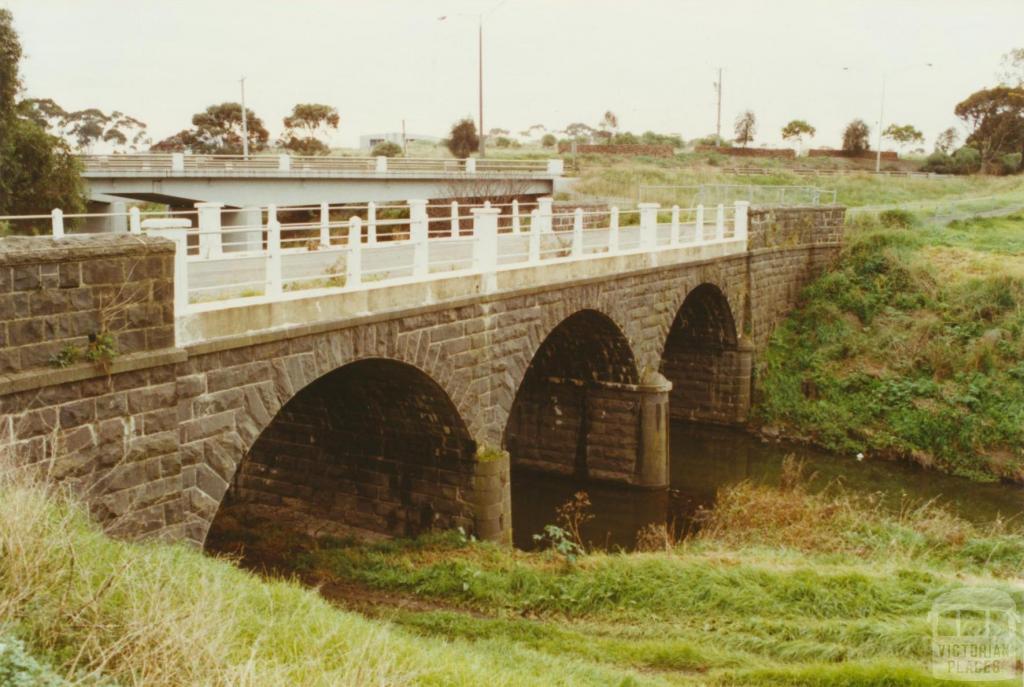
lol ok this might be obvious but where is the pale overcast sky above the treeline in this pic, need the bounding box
[0,0,1024,149]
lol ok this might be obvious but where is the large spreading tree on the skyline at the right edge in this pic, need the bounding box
[953,86,1024,164]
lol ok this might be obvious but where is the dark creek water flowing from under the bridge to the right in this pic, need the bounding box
[512,422,1024,549]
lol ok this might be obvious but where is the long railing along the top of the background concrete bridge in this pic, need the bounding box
[79,153,563,176]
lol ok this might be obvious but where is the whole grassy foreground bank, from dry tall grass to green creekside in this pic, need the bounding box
[8,470,1024,685]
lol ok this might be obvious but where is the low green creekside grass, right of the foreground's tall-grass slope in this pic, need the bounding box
[284,473,1024,685]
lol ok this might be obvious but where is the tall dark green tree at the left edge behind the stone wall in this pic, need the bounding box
[0,8,85,224]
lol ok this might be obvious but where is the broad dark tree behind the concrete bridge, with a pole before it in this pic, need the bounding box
[152,102,270,155]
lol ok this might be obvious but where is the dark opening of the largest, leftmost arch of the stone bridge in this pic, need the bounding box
[206,357,478,548]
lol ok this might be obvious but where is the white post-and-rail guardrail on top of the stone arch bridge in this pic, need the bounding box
[0,198,749,333]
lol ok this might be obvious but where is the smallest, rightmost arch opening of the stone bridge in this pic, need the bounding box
[660,283,752,424]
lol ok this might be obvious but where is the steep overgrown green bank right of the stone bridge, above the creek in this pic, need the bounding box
[756,206,1024,481]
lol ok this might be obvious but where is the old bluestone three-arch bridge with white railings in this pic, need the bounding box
[0,199,844,545]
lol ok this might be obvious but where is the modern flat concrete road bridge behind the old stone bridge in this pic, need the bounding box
[79,153,563,231]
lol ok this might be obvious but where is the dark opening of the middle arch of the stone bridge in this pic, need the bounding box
[502,309,640,478]
